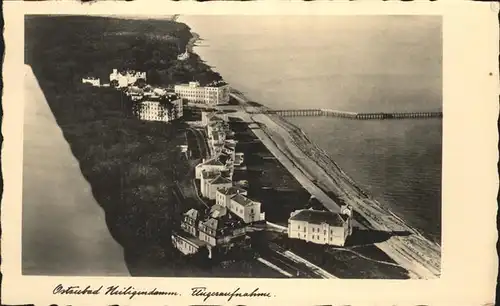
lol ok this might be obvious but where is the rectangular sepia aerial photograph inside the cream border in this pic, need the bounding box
[22,15,443,279]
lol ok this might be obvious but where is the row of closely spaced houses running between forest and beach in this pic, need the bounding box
[172,112,265,258]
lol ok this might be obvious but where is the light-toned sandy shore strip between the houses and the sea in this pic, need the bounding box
[232,94,441,279]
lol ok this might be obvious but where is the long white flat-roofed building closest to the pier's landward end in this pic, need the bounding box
[174,82,230,105]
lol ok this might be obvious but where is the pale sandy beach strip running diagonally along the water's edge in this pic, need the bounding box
[232,93,441,278]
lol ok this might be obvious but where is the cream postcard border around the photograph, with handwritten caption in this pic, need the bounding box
[1,1,499,305]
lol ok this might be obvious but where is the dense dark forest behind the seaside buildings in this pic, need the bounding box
[25,16,250,276]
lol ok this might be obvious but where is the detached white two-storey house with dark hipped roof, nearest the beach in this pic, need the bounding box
[288,206,352,246]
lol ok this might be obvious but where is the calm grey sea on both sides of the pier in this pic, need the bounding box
[180,16,442,241]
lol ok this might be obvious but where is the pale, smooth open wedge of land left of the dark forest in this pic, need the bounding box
[22,66,129,276]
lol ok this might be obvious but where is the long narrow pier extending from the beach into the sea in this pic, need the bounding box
[263,108,443,120]
